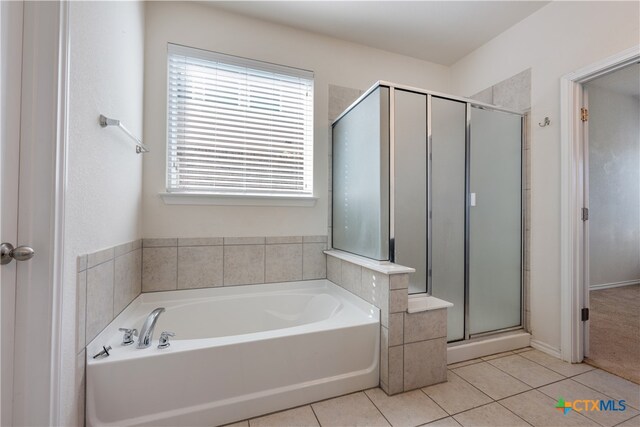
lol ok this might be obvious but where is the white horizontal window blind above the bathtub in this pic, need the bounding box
[167,44,313,196]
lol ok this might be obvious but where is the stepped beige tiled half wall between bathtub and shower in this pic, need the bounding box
[326,251,447,395]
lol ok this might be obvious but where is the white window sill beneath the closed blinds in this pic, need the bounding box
[160,193,318,207]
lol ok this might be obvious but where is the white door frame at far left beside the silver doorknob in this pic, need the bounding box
[0,1,69,425]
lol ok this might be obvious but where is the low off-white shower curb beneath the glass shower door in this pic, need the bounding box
[447,331,531,364]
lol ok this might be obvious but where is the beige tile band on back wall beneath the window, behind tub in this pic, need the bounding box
[142,236,327,292]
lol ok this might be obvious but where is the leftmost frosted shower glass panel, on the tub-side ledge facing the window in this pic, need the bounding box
[333,87,389,260]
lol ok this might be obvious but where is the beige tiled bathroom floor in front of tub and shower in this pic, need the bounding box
[226,348,640,427]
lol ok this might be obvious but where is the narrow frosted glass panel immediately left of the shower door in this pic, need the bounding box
[430,97,466,341]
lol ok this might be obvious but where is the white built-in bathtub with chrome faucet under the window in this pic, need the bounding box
[86,280,380,426]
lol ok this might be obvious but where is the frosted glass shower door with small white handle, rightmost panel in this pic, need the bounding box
[469,108,522,334]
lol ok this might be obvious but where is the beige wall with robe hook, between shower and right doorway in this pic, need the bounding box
[451,2,640,352]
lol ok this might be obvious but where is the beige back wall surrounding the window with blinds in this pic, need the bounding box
[143,2,449,238]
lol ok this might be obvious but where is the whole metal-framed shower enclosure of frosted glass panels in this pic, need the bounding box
[332,82,523,342]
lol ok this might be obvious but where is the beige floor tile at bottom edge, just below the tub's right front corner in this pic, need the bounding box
[311,392,389,427]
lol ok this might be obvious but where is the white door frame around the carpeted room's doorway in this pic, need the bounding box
[560,45,640,363]
